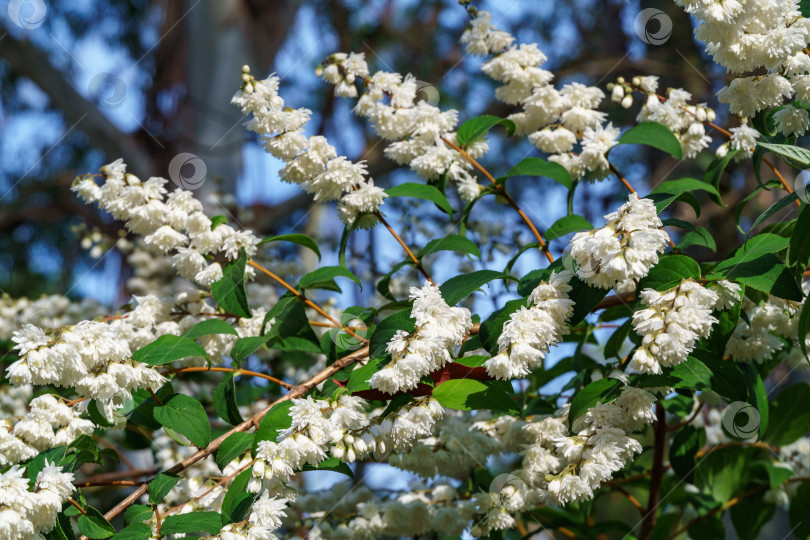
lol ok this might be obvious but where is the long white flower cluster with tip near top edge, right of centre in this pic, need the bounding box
[461,11,620,180]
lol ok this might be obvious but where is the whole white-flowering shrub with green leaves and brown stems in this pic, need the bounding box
[0,0,810,540]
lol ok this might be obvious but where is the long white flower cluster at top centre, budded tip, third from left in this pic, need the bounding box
[319,53,489,201]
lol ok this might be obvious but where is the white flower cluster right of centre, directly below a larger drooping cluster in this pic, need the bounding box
[630,279,741,374]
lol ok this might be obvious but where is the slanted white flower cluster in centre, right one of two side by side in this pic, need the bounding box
[484,271,574,380]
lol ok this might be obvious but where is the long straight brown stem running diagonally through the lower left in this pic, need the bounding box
[97,346,368,521]
